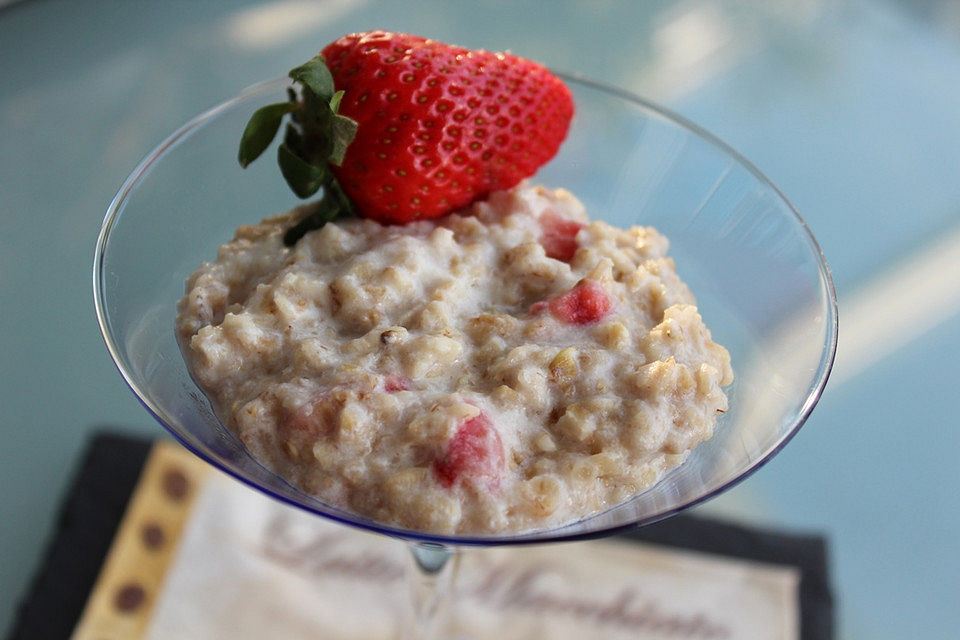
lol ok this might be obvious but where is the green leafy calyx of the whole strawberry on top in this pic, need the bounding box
[237,55,357,246]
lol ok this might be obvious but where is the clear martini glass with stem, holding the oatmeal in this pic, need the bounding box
[93,76,837,637]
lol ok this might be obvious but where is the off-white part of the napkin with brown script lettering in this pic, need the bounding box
[146,473,799,640]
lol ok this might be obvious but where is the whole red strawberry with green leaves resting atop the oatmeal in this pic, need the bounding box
[240,31,573,235]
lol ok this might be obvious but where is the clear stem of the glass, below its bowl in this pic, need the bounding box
[401,542,460,640]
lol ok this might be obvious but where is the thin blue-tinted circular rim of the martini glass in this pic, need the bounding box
[93,72,838,546]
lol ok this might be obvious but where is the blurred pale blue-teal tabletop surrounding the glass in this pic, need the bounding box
[0,0,960,640]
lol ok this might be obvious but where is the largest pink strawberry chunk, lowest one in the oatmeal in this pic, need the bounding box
[433,413,504,489]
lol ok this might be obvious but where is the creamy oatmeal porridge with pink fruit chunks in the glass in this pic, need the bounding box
[177,184,733,533]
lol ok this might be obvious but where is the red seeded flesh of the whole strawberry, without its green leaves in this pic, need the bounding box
[323,31,573,222]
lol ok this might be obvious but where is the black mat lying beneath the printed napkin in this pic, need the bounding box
[7,432,834,640]
